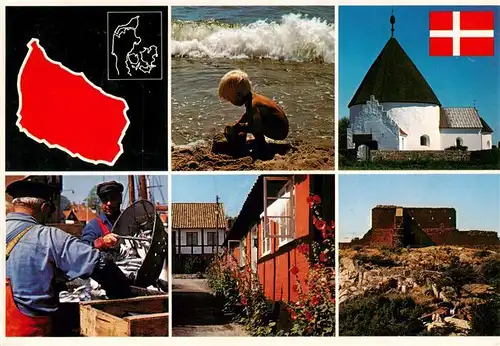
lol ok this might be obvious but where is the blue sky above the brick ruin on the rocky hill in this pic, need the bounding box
[337,174,500,241]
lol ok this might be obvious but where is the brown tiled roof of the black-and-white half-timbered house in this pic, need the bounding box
[171,203,226,229]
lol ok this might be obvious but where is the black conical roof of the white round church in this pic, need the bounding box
[349,37,441,107]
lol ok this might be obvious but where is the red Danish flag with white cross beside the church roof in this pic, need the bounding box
[429,11,495,56]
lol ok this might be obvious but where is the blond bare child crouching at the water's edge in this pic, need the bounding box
[219,70,289,148]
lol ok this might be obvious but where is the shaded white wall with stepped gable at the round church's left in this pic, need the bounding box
[349,99,399,150]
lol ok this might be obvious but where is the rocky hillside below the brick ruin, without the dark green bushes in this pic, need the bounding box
[339,246,500,335]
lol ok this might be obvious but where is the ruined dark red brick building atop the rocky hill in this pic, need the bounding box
[351,205,500,247]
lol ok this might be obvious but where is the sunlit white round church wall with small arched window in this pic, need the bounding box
[382,102,441,150]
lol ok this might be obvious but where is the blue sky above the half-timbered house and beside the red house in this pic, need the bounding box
[172,174,258,217]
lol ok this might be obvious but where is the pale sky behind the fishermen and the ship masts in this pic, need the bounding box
[61,175,168,206]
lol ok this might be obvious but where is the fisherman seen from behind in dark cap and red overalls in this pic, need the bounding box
[5,177,131,337]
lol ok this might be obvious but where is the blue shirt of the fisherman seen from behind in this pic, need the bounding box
[6,213,100,316]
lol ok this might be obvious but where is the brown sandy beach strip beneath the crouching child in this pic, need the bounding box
[172,135,335,171]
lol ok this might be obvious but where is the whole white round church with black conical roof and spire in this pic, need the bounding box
[347,16,493,150]
